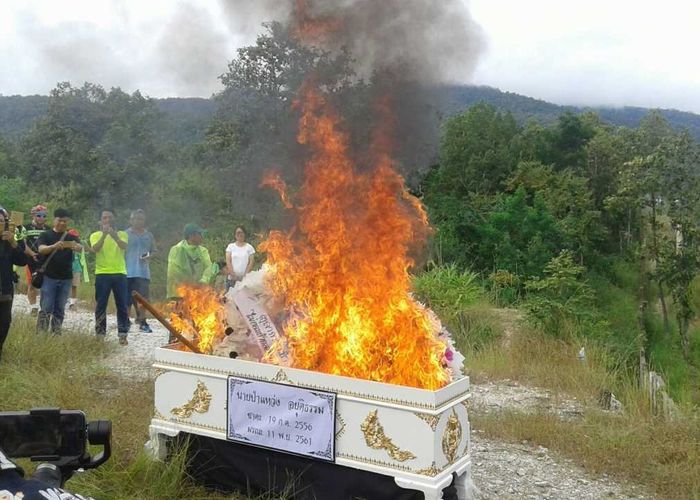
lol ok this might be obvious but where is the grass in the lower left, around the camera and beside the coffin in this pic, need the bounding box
[0,315,252,500]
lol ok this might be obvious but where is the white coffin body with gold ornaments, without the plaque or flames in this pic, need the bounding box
[148,347,471,499]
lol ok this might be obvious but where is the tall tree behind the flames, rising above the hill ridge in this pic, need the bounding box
[203,22,353,217]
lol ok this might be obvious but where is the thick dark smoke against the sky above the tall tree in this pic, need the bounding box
[221,0,483,84]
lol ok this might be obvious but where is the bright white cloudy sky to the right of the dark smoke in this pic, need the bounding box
[470,0,700,112]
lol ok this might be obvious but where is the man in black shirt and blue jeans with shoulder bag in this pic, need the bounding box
[36,208,83,334]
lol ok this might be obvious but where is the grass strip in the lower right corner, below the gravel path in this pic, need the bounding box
[471,412,700,499]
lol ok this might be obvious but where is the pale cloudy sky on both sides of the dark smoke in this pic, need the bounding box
[0,0,700,113]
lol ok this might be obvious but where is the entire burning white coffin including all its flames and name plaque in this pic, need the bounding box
[151,55,470,499]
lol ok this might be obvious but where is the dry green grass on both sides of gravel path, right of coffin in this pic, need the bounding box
[467,322,700,499]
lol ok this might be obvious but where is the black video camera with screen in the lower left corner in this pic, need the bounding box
[0,408,112,487]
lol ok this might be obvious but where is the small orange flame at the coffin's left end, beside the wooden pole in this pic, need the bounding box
[170,285,225,354]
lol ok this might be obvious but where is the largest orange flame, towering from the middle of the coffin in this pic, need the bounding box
[261,82,450,389]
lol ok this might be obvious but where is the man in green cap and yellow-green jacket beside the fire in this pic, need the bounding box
[167,223,211,299]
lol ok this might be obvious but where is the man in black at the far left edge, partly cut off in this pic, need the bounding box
[0,207,27,360]
